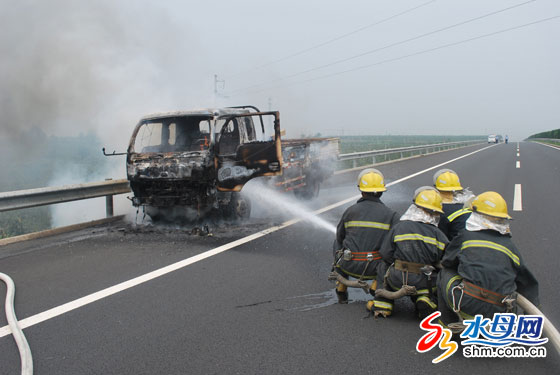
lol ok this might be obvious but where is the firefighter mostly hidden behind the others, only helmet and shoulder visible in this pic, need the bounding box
[434,169,474,241]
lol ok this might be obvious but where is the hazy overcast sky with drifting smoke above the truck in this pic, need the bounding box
[0,0,560,147]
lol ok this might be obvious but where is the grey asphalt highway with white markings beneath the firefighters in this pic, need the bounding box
[0,142,560,375]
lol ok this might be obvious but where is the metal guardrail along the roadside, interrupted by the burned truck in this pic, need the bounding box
[0,140,483,217]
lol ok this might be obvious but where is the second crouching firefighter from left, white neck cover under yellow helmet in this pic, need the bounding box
[370,186,449,319]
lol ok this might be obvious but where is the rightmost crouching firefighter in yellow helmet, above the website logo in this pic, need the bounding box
[437,191,539,324]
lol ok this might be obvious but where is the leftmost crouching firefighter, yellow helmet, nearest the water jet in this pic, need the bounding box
[333,168,398,303]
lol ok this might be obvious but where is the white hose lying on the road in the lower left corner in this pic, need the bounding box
[0,272,33,375]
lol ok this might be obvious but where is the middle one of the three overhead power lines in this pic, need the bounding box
[230,0,536,94]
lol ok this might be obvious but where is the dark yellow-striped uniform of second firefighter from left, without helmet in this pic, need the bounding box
[373,220,448,317]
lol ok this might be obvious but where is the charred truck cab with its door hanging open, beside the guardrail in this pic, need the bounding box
[126,106,282,221]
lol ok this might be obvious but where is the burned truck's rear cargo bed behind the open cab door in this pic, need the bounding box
[270,138,339,199]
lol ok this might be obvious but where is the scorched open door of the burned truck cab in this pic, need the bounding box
[215,112,282,191]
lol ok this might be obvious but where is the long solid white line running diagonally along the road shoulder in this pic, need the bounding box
[0,144,496,337]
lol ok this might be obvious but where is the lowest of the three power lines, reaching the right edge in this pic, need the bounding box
[236,15,560,93]
